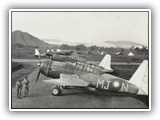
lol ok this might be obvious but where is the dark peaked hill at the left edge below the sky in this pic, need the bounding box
[12,30,52,47]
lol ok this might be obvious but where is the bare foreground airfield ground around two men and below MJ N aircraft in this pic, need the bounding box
[11,60,148,109]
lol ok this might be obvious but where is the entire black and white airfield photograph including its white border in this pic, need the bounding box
[9,9,151,111]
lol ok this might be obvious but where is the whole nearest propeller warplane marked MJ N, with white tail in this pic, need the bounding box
[36,52,148,96]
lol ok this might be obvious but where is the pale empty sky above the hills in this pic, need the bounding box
[12,12,148,45]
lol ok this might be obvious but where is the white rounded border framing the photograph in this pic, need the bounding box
[9,9,151,111]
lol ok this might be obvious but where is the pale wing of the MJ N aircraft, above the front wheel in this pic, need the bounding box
[43,74,90,87]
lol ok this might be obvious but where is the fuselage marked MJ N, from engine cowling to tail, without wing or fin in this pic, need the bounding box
[40,60,139,93]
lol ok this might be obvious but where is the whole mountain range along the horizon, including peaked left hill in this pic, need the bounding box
[12,30,143,48]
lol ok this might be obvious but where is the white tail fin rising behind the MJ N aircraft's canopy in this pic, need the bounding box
[99,54,113,72]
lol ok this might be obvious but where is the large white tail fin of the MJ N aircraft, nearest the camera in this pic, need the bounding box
[129,60,148,95]
